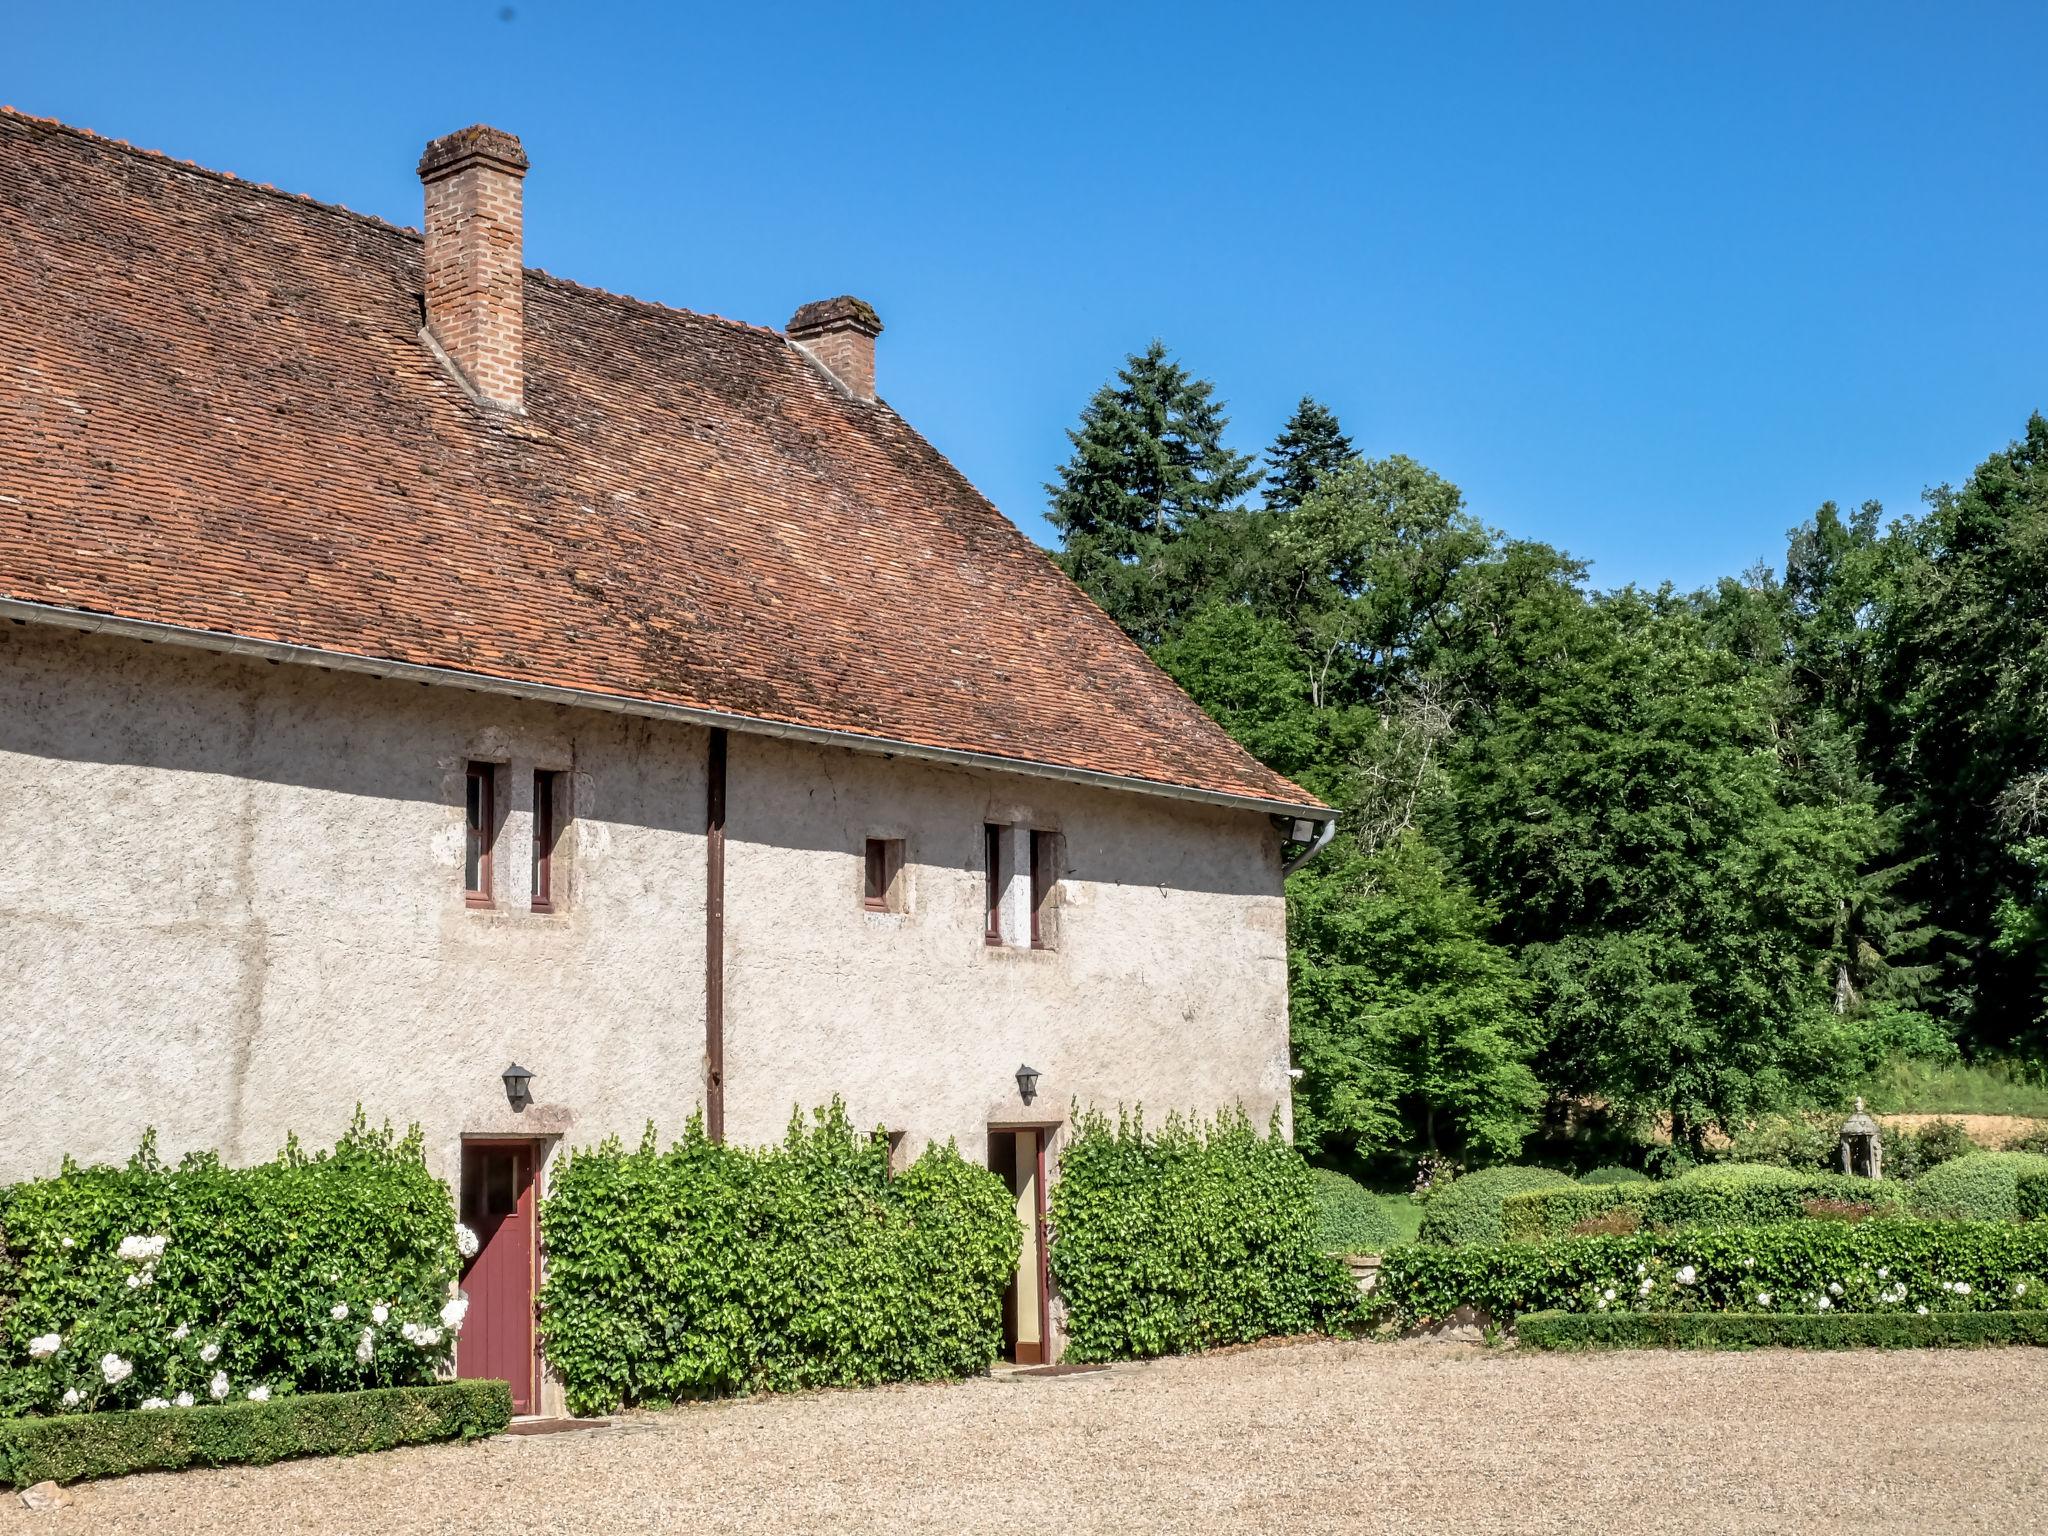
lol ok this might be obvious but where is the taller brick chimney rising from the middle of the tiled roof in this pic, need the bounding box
[420,123,526,412]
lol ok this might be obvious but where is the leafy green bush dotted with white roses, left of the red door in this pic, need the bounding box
[0,1114,459,1419]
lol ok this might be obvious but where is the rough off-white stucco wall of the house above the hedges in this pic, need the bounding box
[0,625,1288,1182]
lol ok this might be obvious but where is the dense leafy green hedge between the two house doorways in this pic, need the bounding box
[541,1102,1022,1413]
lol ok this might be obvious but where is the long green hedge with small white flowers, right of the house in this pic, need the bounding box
[1372,1219,2048,1325]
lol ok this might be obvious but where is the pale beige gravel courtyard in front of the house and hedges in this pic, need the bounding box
[0,1343,2048,1536]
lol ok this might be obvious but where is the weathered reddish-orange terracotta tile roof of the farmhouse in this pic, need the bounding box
[0,113,1315,819]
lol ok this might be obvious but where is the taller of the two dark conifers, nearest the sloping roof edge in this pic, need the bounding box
[1047,342,1257,639]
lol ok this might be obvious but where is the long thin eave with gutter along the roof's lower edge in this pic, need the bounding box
[0,598,1335,821]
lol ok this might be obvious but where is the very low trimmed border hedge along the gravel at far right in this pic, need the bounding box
[1516,1313,2048,1350]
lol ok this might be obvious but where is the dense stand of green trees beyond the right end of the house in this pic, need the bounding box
[1051,344,2048,1163]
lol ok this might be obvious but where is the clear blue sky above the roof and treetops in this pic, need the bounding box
[16,0,2048,586]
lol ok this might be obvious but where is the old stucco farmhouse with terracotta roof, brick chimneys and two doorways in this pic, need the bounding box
[0,113,1333,1411]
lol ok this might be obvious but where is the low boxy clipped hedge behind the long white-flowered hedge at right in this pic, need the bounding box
[1501,1163,1907,1241]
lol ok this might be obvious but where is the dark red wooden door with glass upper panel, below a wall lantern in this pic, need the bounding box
[455,1141,541,1413]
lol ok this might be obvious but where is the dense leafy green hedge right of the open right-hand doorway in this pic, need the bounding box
[1051,1112,1362,1360]
